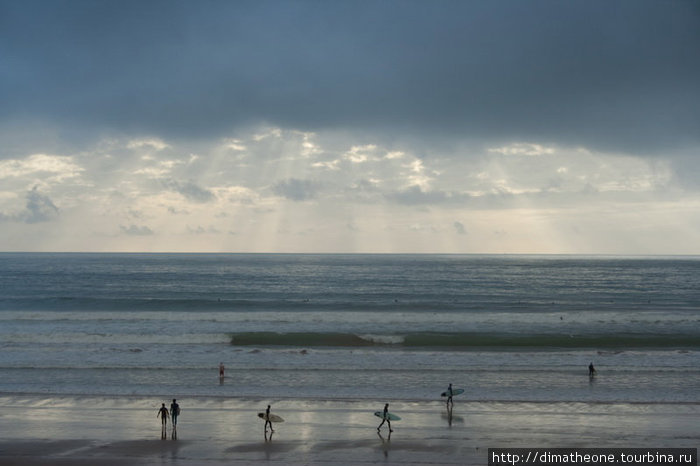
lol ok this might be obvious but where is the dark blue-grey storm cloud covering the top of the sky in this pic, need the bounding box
[0,0,700,152]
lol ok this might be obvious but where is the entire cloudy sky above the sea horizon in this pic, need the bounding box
[0,0,700,255]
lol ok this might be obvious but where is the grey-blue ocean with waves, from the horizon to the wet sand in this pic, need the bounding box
[0,253,700,403]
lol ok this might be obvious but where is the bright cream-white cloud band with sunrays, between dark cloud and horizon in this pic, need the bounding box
[0,129,700,252]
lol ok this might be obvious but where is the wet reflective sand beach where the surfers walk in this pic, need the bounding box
[0,396,700,466]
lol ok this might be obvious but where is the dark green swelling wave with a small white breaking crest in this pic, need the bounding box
[230,332,700,349]
